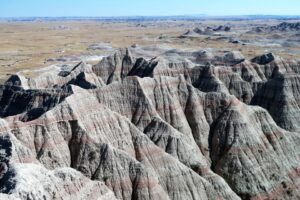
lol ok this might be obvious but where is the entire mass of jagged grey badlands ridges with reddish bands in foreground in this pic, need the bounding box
[0,47,300,200]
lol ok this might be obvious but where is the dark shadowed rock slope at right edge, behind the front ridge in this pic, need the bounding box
[251,73,300,131]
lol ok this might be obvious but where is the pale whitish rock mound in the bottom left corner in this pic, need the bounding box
[1,164,116,200]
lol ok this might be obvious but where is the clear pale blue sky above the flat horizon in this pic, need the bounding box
[0,0,300,17]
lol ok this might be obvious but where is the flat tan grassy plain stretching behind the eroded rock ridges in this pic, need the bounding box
[0,20,300,82]
